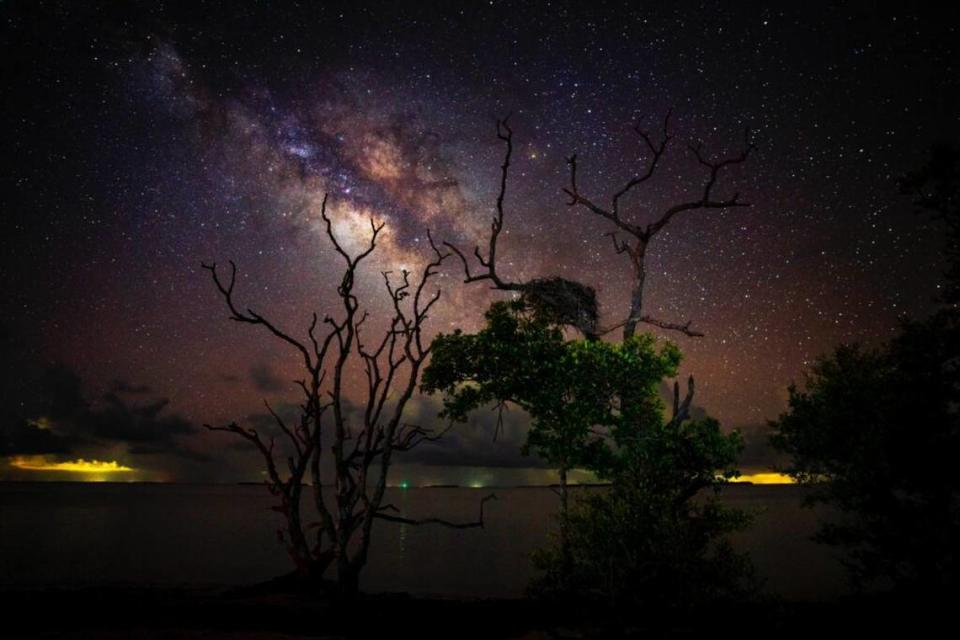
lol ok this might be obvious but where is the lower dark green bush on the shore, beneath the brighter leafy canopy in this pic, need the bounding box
[532,417,757,609]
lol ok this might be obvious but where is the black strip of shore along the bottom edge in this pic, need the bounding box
[0,583,953,640]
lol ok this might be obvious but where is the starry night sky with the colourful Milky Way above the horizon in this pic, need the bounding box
[0,2,960,482]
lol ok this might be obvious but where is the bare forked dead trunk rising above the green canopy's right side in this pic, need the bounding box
[563,112,754,339]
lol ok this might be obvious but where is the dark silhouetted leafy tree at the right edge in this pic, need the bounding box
[771,147,960,593]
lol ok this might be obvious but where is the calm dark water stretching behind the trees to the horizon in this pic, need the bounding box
[0,483,845,599]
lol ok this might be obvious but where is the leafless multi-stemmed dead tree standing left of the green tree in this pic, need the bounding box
[202,196,495,596]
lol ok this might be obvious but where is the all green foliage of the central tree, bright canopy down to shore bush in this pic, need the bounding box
[422,300,754,606]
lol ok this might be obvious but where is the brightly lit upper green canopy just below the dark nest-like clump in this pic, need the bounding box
[421,300,680,472]
